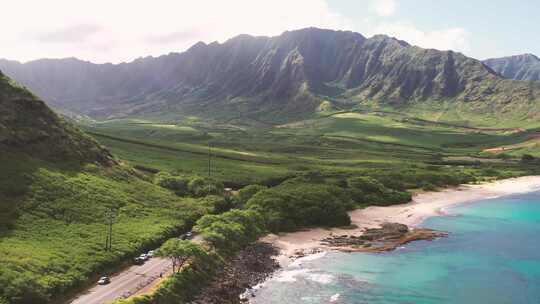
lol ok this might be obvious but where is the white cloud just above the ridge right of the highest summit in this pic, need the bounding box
[367,23,471,53]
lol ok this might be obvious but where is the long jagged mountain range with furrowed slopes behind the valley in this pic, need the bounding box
[0,28,540,122]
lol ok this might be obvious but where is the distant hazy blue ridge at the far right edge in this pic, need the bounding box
[484,54,540,81]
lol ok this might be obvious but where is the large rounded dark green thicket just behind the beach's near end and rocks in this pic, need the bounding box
[246,182,353,232]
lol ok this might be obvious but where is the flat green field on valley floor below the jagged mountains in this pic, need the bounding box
[84,112,529,187]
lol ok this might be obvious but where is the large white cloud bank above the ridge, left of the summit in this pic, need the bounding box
[0,0,351,62]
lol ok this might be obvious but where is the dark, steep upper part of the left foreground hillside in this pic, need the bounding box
[0,72,112,164]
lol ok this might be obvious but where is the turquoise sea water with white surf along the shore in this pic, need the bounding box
[253,192,540,304]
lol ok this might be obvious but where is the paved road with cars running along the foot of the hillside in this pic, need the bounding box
[71,258,171,304]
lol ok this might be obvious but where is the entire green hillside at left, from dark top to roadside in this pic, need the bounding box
[0,76,209,304]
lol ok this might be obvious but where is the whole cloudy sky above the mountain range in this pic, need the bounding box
[0,0,540,63]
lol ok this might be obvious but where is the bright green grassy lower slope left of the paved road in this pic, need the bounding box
[0,153,214,303]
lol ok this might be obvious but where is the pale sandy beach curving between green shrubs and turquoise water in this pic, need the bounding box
[263,176,540,267]
